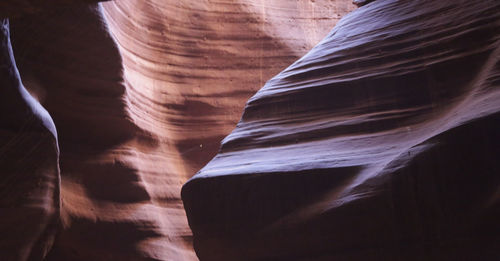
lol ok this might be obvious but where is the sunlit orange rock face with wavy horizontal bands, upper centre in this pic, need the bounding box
[98,0,353,179]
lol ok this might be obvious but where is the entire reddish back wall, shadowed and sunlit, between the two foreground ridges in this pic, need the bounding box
[4,0,353,261]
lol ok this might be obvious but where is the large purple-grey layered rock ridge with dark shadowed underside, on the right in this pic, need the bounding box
[182,0,500,260]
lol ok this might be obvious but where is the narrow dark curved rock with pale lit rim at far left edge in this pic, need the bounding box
[0,19,60,261]
